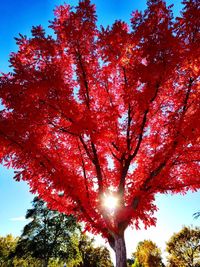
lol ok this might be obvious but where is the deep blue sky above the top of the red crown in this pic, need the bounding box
[0,0,184,71]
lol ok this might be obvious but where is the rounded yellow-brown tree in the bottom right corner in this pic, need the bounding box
[166,227,200,267]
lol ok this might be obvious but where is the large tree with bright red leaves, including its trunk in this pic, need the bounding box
[0,0,200,267]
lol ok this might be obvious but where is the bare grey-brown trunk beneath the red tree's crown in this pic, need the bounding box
[114,233,127,267]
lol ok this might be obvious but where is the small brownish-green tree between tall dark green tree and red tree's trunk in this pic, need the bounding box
[78,234,113,267]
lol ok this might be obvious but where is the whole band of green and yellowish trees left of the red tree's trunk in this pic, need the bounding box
[0,197,113,267]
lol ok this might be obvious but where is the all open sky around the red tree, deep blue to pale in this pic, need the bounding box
[0,0,200,264]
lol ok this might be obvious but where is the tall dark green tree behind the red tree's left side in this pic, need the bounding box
[14,197,80,267]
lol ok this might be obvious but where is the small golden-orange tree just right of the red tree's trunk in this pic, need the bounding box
[133,240,164,267]
